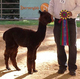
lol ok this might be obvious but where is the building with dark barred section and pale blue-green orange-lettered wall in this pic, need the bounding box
[0,0,80,20]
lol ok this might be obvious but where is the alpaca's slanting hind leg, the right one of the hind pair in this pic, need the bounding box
[10,48,20,70]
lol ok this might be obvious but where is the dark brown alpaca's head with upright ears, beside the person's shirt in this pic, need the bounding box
[39,10,53,25]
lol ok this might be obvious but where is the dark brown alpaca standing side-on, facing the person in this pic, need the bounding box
[3,11,52,74]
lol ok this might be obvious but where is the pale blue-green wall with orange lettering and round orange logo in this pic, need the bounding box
[20,0,50,19]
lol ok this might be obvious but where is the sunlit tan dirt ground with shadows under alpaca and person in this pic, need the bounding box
[0,25,80,79]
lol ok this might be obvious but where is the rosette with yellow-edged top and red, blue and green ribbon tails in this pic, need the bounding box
[59,10,70,46]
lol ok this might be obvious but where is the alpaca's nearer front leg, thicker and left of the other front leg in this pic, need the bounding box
[27,50,33,74]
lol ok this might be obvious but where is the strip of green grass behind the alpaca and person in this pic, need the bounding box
[0,20,80,27]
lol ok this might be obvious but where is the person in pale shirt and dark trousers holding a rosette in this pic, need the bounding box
[48,0,80,76]
